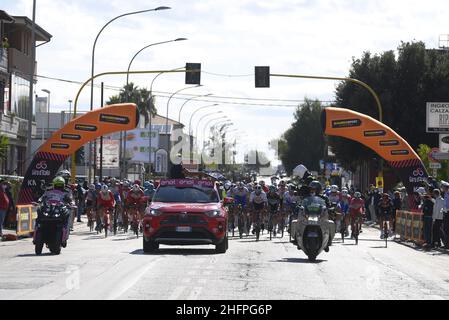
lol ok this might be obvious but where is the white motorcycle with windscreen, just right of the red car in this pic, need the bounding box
[292,196,335,262]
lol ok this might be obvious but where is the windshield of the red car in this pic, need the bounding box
[153,186,219,203]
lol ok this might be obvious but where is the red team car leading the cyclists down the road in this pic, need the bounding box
[143,179,228,253]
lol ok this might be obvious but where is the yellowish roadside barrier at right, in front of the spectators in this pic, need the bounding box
[396,210,424,244]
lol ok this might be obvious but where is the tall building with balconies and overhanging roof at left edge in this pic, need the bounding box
[0,10,52,176]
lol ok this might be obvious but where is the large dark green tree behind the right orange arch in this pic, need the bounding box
[329,42,449,168]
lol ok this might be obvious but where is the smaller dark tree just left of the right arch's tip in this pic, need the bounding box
[278,98,325,173]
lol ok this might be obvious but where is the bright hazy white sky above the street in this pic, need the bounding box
[0,0,449,165]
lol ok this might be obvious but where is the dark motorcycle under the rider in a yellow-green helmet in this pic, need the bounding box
[33,202,72,255]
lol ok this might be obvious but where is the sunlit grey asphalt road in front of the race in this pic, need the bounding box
[0,223,449,300]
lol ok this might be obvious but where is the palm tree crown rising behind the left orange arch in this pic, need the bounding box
[107,82,157,125]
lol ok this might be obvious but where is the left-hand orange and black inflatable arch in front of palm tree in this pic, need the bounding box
[17,103,139,204]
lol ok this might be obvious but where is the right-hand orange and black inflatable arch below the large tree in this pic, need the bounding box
[321,108,428,193]
